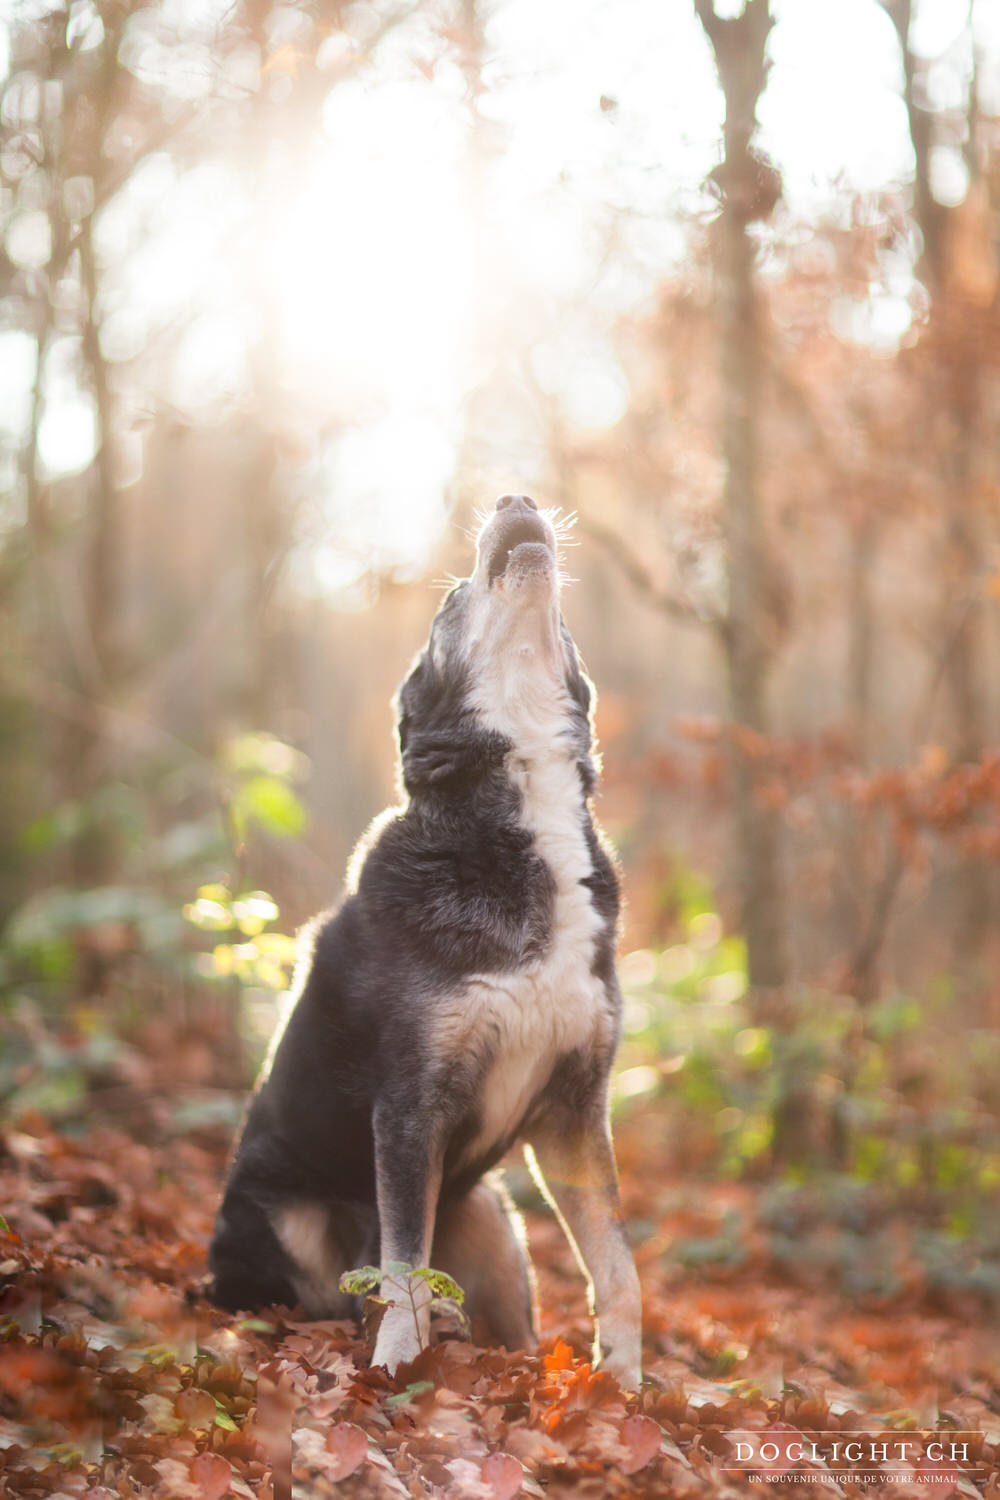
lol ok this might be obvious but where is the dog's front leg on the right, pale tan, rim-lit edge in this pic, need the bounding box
[526,1104,642,1391]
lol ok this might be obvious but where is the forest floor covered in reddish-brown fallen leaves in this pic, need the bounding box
[0,1092,1000,1500]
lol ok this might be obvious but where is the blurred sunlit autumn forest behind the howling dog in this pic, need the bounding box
[0,0,1000,1494]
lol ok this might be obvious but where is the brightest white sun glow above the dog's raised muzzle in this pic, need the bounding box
[264,84,478,417]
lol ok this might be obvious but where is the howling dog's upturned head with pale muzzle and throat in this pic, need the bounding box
[399,495,597,795]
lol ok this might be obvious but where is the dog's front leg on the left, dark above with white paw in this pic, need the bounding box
[372,1104,441,1376]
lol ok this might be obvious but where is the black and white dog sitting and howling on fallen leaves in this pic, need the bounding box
[210,495,640,1389]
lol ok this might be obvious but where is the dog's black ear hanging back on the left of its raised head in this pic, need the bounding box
[397,651,510,797]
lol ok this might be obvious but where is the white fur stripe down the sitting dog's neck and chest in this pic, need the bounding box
[448,752,609,1160]
